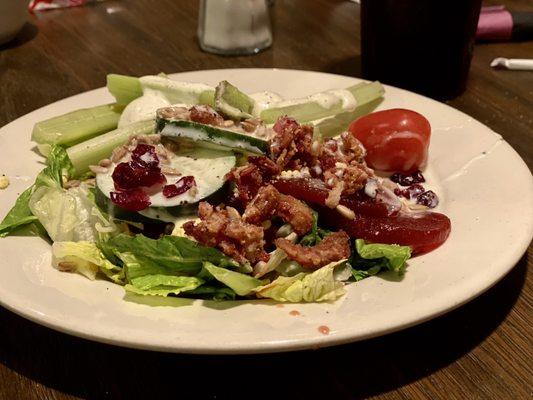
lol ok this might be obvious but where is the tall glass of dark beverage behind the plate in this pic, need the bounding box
[361,0,481,100]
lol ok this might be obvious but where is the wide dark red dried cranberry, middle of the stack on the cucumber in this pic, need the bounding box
[111,163,167,190]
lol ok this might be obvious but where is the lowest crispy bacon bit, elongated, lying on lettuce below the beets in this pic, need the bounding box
[275,231,350,270]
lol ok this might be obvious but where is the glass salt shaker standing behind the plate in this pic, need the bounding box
[198,0,272,55]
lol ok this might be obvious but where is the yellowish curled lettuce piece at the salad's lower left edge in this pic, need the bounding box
[52,241,124,283]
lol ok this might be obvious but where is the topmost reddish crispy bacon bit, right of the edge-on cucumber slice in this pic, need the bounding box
[270,117,314,169]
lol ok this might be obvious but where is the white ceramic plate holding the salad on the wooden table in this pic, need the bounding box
[0,69,533,353]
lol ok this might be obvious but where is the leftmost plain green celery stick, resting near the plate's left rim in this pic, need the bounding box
[31,104,122,146]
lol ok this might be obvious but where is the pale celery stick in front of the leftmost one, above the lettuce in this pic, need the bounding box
[67,120,155,175]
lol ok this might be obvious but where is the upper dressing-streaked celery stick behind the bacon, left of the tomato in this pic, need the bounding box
[260,82,384,123]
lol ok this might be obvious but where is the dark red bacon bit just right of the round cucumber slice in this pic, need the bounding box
[225,156,281,204]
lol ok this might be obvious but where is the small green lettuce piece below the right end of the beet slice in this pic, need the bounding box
[350,239,411,281]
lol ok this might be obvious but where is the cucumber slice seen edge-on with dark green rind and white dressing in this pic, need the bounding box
[156,116,269,154]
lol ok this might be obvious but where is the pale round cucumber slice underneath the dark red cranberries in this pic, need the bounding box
[96,147,235,209]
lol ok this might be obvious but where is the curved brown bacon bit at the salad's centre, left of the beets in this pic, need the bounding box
[243,185,313,235]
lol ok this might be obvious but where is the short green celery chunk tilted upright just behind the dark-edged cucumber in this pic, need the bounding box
[215,81,255,119]
